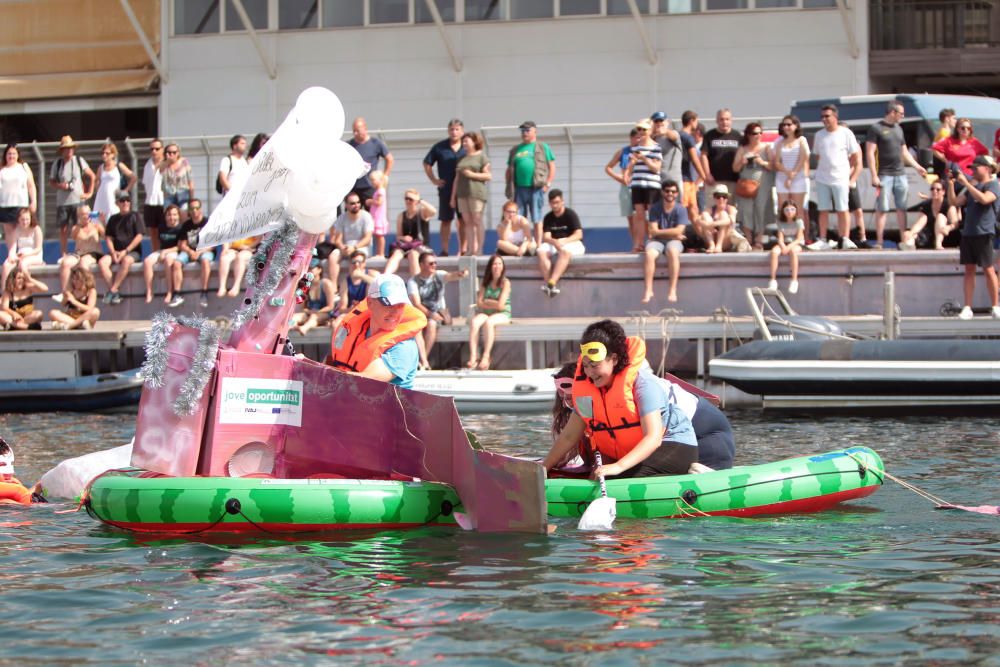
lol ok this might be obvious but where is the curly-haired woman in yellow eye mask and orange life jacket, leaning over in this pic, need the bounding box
[543,320,698,478]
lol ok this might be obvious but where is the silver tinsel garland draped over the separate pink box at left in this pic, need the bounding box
[142,313,222,415]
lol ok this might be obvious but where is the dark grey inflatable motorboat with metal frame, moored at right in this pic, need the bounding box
[709,288,1000,410]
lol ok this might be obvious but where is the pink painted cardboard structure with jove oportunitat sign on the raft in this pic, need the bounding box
[132,227,547,533]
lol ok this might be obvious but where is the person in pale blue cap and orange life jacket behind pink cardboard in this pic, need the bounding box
[326,273,427,389]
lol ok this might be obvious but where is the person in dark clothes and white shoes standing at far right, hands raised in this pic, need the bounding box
[947,155,1000,320]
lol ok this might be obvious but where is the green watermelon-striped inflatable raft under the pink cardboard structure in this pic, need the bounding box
[84,468,460,535]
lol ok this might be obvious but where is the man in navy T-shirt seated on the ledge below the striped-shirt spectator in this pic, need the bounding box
[642,181,693,303]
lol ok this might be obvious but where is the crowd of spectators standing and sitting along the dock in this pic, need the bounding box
[0,102,1000,342]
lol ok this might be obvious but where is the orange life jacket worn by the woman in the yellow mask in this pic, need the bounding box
[573,336,646,462]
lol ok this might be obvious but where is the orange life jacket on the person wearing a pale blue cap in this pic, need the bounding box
[326,299,427,372]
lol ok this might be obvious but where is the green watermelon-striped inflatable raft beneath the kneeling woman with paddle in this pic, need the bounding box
[545,447,884,519]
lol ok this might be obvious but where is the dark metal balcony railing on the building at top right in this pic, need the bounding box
[869,0,1000,50]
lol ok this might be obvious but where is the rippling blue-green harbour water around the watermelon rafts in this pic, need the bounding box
[0,412,1000,667]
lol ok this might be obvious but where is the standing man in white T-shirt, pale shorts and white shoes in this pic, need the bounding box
[808,104,861,250]
